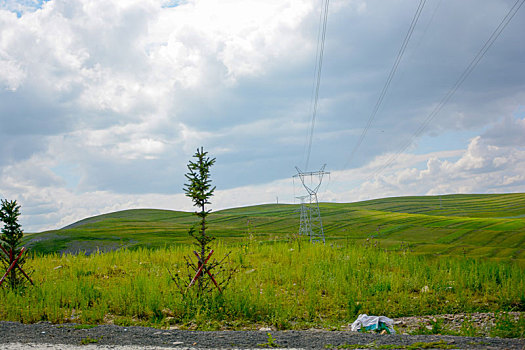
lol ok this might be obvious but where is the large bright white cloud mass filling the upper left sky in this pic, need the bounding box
[0,0,318,161]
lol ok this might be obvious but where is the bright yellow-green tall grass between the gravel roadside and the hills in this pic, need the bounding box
[0,241,525,329]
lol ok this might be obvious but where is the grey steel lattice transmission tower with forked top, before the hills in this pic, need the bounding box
[293,164,330,243]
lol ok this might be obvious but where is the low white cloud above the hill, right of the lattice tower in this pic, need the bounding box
[325,118,525,201]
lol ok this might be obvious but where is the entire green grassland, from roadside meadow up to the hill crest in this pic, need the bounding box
[0,194,525,336]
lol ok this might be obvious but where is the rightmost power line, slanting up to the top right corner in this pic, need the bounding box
[374,0,525,176]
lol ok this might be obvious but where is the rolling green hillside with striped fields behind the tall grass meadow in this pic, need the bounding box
[27,193,525,261]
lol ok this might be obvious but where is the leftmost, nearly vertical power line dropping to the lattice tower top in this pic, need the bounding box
[305,0,330,171]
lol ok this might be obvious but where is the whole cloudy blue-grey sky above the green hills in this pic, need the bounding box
[0,0,525,232]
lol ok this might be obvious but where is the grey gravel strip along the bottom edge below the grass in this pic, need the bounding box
[0,321,525,350]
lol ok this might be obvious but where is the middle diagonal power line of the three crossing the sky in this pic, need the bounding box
[343,0,426,169]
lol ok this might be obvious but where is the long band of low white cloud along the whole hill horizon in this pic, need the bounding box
[0,119,525,231]
